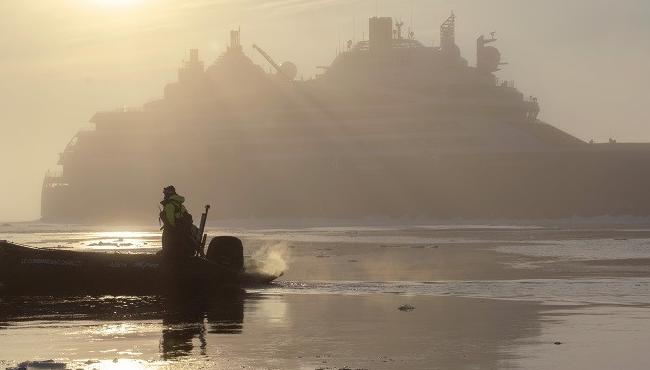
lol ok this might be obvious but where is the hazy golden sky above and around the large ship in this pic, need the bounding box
[0,0,650,220]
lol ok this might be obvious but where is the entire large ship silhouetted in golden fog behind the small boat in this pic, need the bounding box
[42,14,650,223]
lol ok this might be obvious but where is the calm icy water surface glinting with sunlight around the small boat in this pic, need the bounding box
[0,226,650,369]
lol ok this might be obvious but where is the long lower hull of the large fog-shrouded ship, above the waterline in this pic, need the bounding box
[43,144,650,224]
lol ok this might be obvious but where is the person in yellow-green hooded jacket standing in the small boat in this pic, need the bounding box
[160,186,195,258]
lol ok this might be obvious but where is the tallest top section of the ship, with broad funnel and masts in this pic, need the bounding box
[319,13,518,91]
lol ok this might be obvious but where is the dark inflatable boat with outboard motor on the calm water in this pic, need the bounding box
[0,236,278,295]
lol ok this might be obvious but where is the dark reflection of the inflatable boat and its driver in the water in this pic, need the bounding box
[0,292,246,360]
